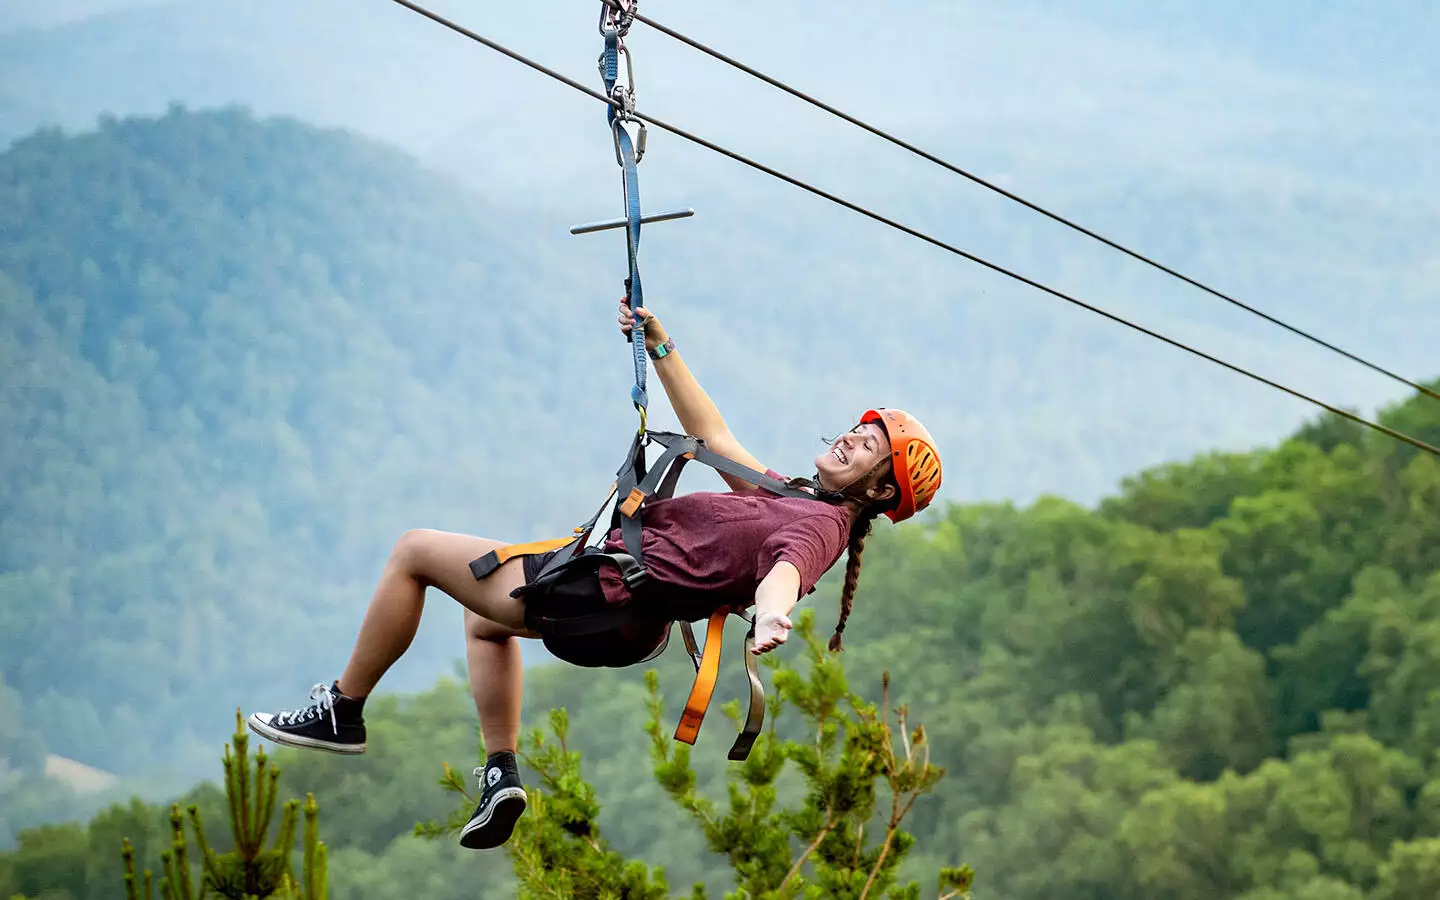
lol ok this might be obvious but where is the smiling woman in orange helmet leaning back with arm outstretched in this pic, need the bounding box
[249,301,940,848]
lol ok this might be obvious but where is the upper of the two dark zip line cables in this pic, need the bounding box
[600,0,1440,400]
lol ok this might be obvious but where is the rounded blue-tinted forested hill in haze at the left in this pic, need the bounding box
[0,109,634,800]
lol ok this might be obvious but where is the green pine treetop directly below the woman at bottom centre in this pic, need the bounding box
[416,611,973,900]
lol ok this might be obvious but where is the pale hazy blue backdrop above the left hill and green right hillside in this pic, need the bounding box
[0,0,1440,500]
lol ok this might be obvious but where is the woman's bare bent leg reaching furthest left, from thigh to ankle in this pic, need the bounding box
[340,530,528,697]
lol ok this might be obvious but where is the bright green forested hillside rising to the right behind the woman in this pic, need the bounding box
[8,385,1440,900]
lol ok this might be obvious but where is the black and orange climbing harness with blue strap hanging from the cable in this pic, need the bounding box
[469,0,783,760]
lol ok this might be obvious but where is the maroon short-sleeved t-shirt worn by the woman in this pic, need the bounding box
[599,469,850,621]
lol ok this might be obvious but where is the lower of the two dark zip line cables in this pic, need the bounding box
[380,0,1440,458]
